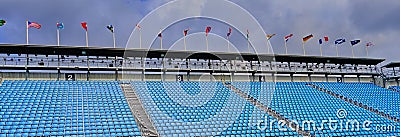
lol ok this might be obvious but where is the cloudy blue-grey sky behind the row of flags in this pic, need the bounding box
[0,0,400,64]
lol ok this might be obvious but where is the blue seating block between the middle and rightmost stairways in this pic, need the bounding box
[233,82,399,136]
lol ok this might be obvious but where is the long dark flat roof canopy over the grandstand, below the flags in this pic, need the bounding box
[0,44,386,67]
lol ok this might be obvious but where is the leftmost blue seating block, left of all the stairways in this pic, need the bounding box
[0,81,140,137]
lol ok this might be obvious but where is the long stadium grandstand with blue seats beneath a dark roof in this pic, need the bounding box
[0,44,400,137]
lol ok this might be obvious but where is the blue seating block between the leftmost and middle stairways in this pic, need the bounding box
[132,81,298,136]
